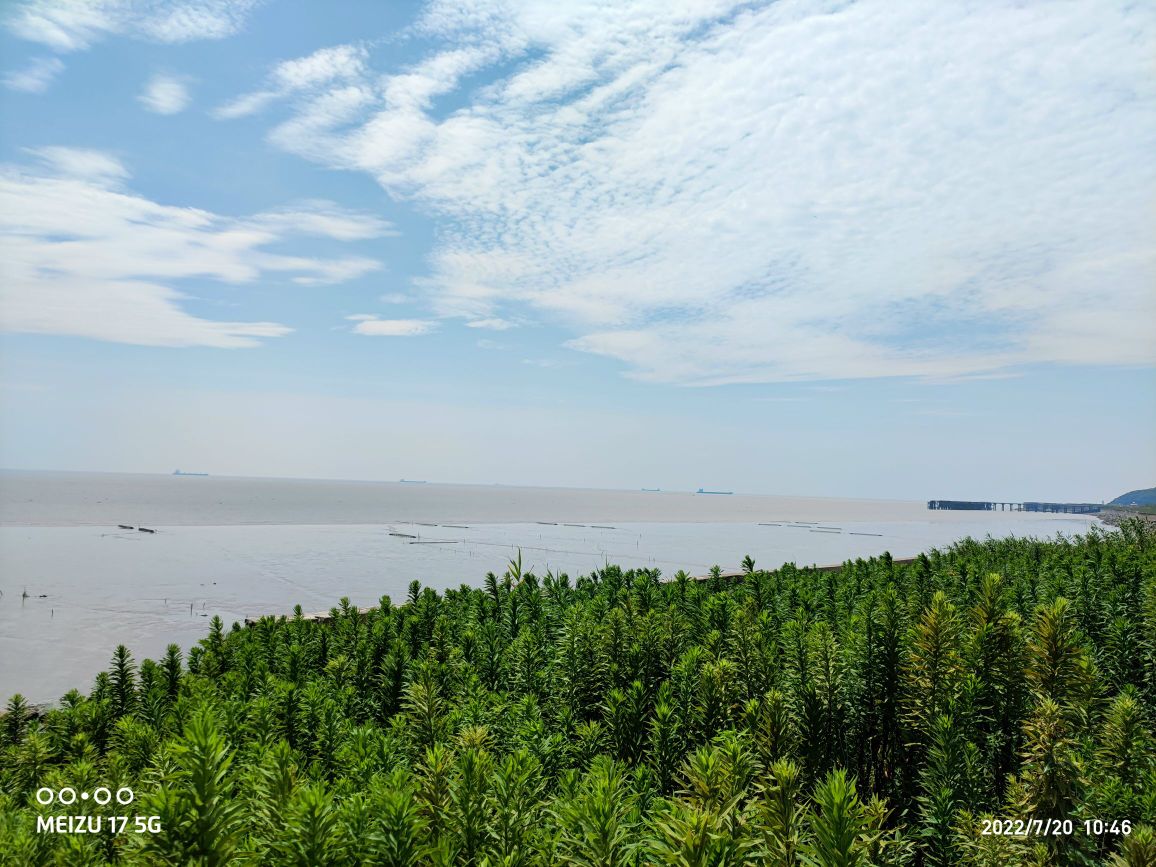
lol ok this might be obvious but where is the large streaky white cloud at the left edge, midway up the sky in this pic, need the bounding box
[0,147,387,347]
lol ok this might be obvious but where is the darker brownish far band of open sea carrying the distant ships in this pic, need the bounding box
[0,470,1031,526]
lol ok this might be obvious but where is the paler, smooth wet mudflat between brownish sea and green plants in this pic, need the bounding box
[0,515,1095,701]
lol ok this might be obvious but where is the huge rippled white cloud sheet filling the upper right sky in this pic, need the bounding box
[227,0,1156,384]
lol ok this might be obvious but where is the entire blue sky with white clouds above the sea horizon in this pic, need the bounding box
[0,0,1156,501]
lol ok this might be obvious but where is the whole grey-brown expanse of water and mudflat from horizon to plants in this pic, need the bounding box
[0,470,1098,704]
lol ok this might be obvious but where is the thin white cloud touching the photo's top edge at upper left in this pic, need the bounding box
[5,0,262,52]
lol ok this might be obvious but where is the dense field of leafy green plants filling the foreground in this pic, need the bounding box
[0,523,1156,867]
